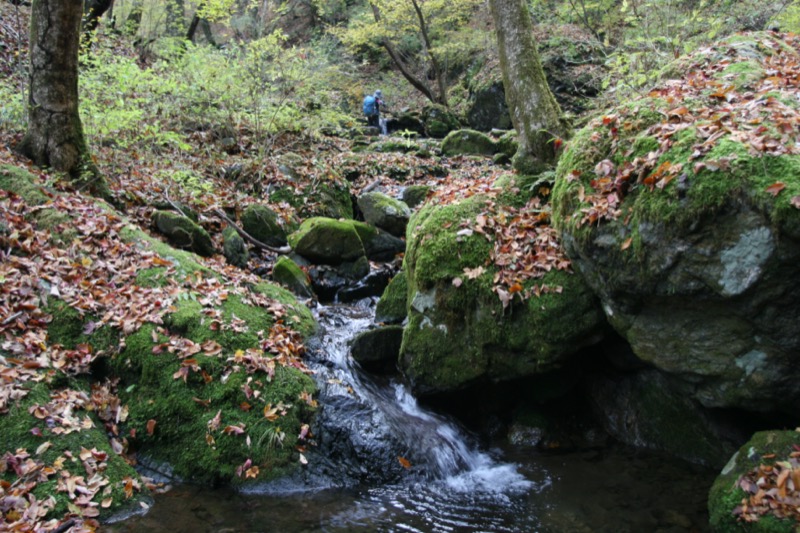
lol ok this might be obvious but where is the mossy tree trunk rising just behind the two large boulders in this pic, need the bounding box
[489,0,568,174]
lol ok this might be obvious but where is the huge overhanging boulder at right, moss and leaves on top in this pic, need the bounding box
[553,34,800,413]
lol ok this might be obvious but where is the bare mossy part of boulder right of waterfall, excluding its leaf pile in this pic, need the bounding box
[400,195,602,394]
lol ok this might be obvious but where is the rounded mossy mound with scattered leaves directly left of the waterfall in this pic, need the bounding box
[110,283,316,484]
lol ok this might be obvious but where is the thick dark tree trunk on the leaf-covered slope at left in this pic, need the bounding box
[18,0,108,196]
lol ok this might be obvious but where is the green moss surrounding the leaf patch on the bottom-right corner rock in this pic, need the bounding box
[708,431,800,533]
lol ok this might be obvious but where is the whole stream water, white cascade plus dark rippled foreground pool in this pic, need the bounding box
[109,300,714,533]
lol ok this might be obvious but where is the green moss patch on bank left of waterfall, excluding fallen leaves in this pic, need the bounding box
[108,316,315,484]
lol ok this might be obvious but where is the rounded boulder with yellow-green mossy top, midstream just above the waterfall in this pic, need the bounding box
[289,217,366,265]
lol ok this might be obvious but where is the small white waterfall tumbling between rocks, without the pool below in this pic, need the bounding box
[310,300,532,492]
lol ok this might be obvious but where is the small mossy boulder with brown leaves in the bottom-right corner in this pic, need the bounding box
[708,430,800,533]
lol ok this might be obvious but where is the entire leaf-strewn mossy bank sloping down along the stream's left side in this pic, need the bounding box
[0,166,316,530]
